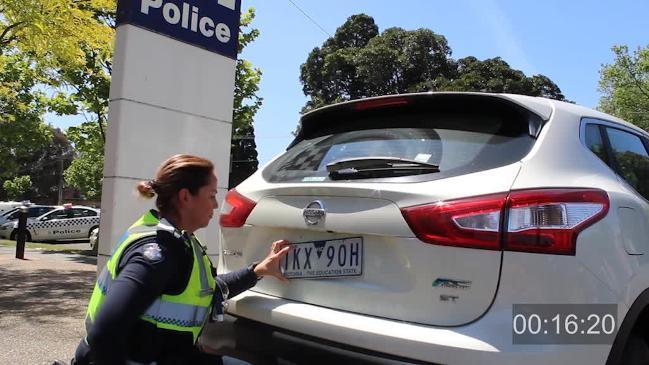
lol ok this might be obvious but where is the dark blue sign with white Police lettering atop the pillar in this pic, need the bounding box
[117,0,241,59]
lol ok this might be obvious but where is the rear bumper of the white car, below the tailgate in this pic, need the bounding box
[201,291,611,365]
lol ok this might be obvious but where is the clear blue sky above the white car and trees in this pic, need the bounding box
[47,0,649,164]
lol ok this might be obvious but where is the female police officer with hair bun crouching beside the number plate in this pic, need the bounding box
[72,155,290,365]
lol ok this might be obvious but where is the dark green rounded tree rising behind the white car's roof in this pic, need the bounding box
[300,14,564,112]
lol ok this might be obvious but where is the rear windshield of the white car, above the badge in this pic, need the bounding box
[263,109,535,182]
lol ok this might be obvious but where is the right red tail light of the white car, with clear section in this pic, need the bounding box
[401,189,609,255]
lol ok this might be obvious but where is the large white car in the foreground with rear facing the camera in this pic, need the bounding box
[215,93,649,365]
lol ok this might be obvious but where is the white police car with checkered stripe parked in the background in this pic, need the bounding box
[0,204,99,241]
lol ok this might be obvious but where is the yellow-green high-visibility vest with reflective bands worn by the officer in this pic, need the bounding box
[86,212,216,343]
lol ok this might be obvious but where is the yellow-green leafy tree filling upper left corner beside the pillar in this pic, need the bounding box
[0,0,117,201]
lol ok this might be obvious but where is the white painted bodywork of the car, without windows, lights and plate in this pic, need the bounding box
[214,94,649,364]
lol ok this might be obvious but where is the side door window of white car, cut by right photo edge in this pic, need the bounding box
[606,128,649,200]
